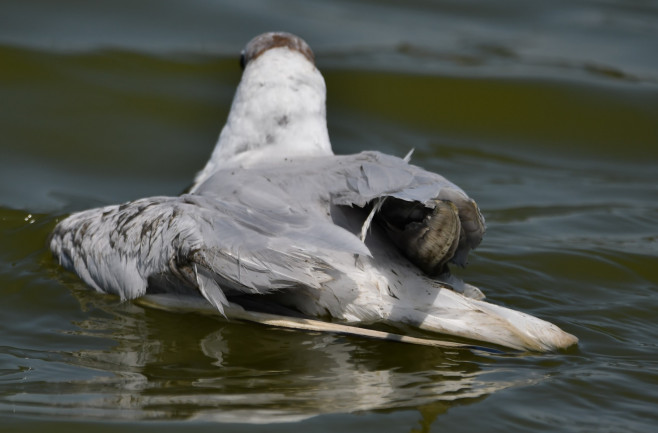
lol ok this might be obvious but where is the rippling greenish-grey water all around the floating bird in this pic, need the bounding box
[0,0,658,432]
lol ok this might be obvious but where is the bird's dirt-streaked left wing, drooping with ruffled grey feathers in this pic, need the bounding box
[50,195,369,311]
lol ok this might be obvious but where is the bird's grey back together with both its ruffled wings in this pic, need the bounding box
[50,152,482,311]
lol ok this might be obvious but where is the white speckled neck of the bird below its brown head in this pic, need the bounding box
[196,48,332,184]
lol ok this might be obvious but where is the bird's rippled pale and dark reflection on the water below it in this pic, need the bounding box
[1,290,540,423]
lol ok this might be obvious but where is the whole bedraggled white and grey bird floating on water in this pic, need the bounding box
[50,33,578,351]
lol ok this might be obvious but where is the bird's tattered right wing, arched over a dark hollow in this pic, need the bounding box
[196,152,485,264]
